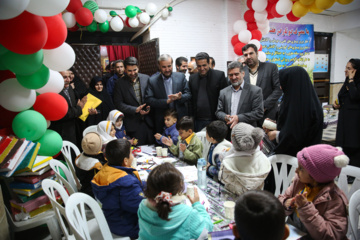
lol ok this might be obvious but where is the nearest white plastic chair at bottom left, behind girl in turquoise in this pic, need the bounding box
[65,193,130,240]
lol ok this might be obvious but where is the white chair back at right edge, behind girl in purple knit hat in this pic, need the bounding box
[337,165,360,200]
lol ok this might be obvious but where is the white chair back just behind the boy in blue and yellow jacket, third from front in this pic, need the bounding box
[49,159,77,195]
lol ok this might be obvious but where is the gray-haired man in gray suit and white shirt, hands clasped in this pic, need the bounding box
[216,61,264,129]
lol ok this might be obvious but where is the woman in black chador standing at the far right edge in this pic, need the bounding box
[334,58,360,167]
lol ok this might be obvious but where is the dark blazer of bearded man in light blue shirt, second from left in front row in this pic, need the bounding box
[145,72,191,133]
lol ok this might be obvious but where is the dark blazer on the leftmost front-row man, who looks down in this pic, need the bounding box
[114,73,153,132]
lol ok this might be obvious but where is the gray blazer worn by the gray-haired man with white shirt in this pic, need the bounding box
[216,82,264,127]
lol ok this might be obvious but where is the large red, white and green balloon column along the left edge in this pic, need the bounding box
[0,0,76,156]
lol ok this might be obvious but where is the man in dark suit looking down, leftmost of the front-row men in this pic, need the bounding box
[114,57,154,145]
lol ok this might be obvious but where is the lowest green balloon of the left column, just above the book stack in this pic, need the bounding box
[37,129,62,156]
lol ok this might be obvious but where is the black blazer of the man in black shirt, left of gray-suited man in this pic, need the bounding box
[189,69,228,120]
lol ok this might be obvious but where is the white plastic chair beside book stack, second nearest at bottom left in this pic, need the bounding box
[41,179,75,239]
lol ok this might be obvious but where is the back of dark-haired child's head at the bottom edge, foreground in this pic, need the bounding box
[232,190,289,240]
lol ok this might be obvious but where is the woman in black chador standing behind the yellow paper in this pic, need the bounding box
[86,76,115,126]
